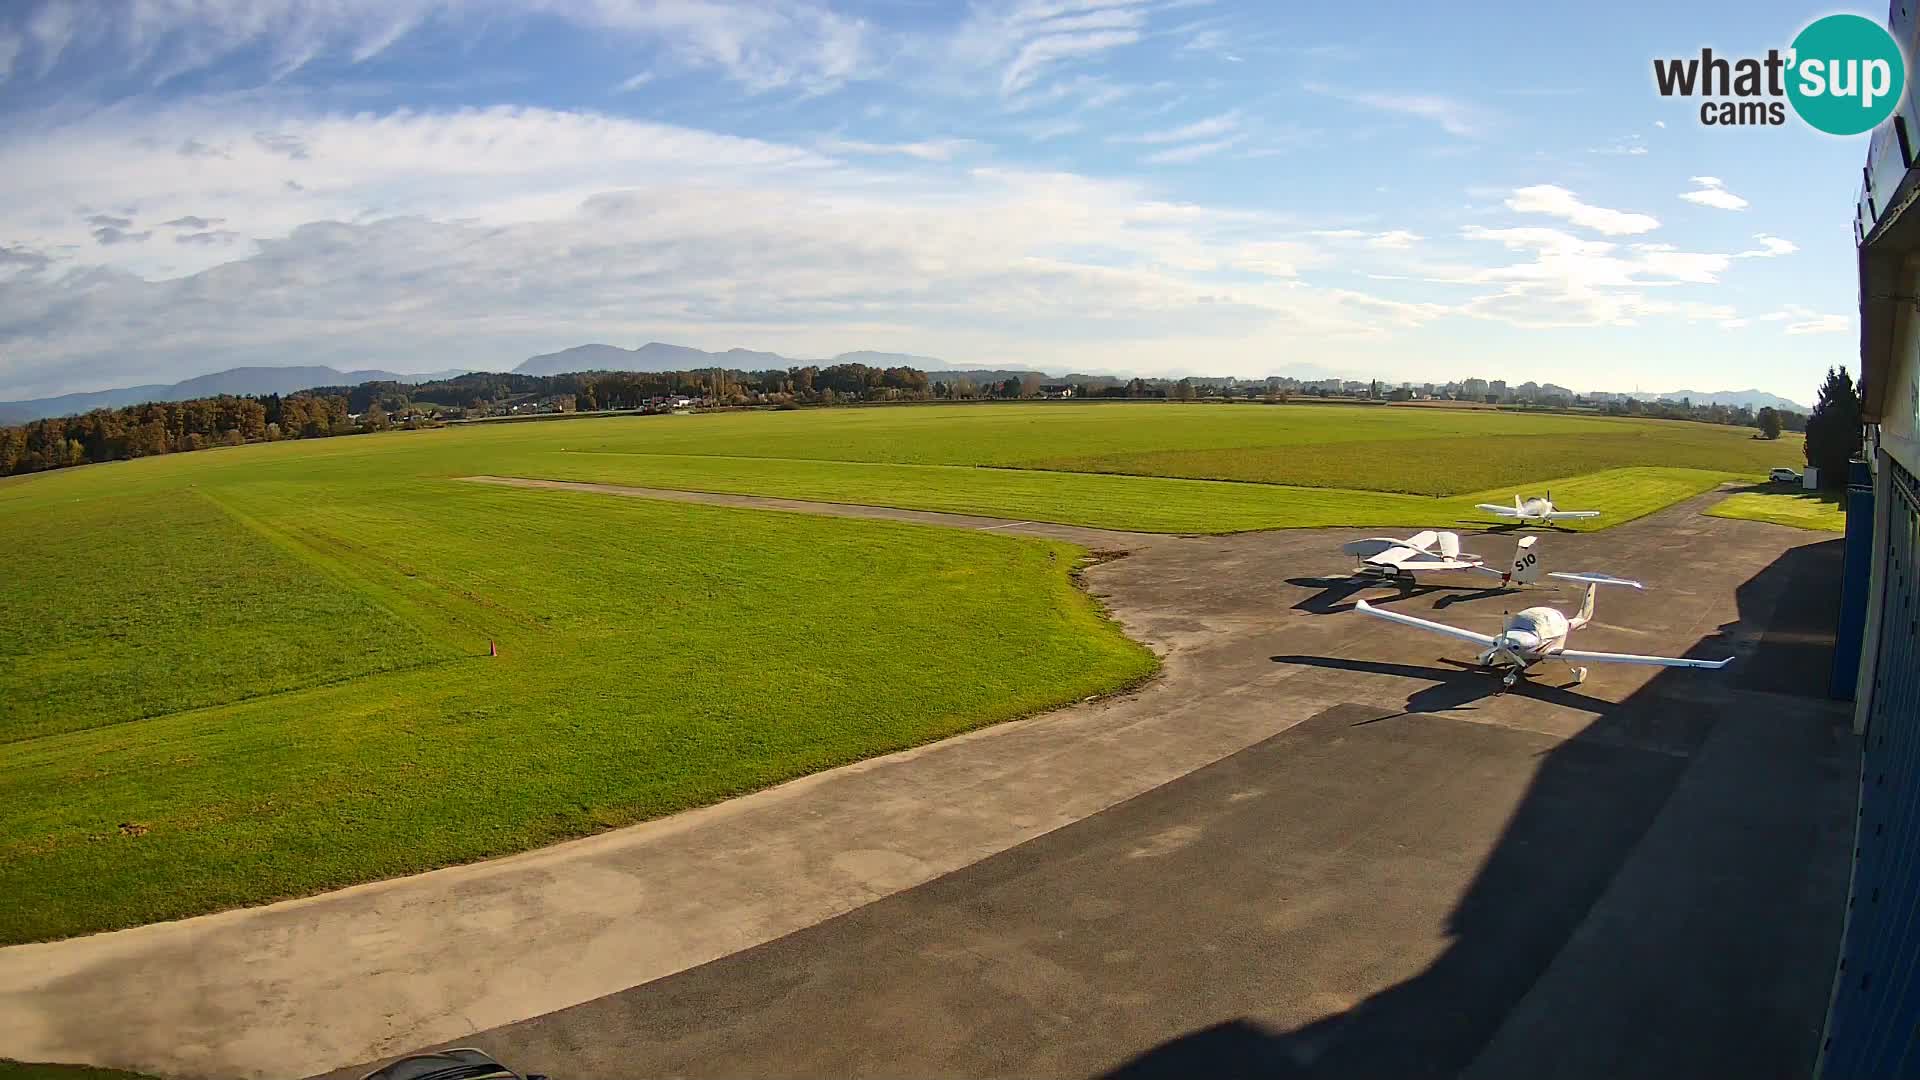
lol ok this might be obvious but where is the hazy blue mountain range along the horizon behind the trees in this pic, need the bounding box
[0,342,1811,425]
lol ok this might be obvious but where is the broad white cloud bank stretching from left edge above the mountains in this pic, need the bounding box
[0,99,1444,396]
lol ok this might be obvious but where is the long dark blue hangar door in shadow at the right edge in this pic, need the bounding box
[1820,461,1920,1080]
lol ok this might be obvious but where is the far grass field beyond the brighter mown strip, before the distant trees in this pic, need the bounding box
[441,402,1801,496]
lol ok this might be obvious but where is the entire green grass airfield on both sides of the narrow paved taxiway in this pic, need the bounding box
[0,397,1799,944]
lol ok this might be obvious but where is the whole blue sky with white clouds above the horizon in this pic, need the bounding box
[0,0,1885,402]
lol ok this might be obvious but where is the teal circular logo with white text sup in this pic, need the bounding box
[1788,15,1907,135]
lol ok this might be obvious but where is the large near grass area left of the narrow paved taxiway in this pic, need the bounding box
[0,434,1154,942]
